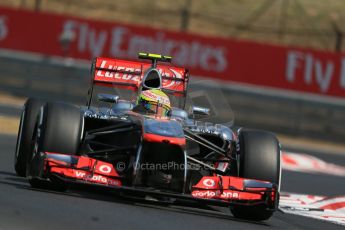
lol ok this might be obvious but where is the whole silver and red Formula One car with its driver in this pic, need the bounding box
[15,53,281,220]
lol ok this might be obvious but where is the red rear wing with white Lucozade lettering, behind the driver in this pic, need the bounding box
[87,57,189,106]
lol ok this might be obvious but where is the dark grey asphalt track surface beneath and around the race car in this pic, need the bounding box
[0,135,345,230]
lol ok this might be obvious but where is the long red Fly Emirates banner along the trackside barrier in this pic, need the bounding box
[0,8,345,97]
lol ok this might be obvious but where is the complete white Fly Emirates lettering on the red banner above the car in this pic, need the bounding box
[60,19,228,72]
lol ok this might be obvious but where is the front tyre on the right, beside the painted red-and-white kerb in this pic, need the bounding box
[231,130,281,221]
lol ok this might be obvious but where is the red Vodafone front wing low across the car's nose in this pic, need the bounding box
[35,152,279,210]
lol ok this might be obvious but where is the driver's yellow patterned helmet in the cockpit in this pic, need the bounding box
[136,89,171,117]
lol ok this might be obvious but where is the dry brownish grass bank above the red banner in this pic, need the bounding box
[0,0,345,50]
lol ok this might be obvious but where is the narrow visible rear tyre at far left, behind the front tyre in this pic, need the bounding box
[14,98,44,177]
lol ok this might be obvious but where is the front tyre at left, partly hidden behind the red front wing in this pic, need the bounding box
[27,102,83,191]
